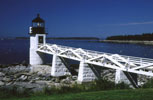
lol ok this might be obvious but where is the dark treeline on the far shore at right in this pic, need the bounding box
[106,33,153,41]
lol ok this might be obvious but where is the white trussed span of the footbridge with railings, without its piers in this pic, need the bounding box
[37,44,153,76]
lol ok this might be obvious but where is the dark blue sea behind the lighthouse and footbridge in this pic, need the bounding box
[0,39,153,64]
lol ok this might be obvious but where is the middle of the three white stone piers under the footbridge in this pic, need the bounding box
[78,62,97,83]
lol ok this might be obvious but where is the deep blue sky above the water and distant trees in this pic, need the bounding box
[0,0,153,38]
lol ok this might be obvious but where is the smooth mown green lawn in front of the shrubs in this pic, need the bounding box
[0,89,153,100]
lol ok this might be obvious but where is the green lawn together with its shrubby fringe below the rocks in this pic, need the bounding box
[0,79,153,100]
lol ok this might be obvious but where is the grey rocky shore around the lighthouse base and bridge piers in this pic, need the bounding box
[0,65,149,92]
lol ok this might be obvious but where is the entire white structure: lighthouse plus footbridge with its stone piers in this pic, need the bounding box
[29,14,153,87]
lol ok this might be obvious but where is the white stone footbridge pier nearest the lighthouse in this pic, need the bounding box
[51,54,70,77]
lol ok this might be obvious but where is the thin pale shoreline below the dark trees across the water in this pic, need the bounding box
[99,40,153,45]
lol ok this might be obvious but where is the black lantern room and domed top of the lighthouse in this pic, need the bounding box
[30,14,46,35]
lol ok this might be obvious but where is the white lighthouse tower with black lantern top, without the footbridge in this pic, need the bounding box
[29,14,47,65]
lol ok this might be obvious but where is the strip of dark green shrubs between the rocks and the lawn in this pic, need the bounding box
[0,79,131,97]
